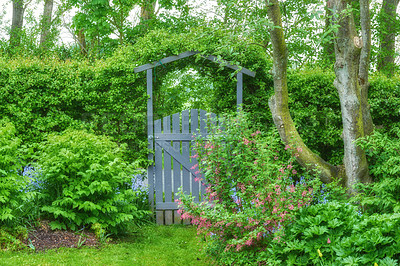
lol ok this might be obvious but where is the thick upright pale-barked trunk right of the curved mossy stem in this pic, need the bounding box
[331,0,372,193]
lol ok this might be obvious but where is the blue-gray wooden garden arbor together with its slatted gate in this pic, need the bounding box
[134,51,255,224]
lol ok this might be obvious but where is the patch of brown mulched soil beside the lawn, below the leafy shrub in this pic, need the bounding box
[25,222,100,251]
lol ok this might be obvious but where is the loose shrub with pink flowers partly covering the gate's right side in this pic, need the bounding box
[177,113,319,262]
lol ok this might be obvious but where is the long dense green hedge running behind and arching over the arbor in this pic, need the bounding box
[0,29,400,164]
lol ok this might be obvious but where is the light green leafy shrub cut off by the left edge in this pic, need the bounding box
[0,121,23,224]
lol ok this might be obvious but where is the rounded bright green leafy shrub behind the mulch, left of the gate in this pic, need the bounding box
[36,130,150,232]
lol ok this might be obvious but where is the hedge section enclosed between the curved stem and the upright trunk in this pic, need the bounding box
[288,69,343,164]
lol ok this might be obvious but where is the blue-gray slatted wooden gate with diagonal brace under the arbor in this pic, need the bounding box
[148,109,215,224]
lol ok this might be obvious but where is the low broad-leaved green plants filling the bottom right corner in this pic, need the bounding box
[266,201,400,265]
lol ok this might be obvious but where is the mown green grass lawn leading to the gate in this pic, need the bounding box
[0,225,214,266]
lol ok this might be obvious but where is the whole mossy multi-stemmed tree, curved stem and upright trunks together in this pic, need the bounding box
[266,0,373,193]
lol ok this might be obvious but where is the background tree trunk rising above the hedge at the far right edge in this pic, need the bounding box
[378,0,399,76]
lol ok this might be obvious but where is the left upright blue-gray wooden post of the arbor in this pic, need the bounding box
[147,69,154,210]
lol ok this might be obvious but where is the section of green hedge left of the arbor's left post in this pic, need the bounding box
[0,55,147,162]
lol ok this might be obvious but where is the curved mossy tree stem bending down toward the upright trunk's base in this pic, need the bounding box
[266,0,343,183]
